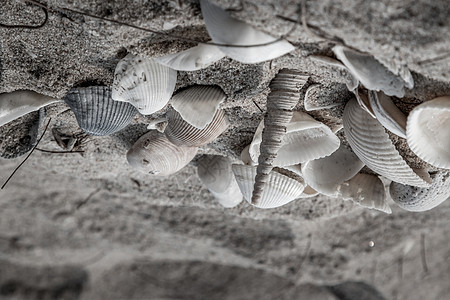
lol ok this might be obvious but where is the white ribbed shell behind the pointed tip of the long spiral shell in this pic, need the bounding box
[232,165,305,208]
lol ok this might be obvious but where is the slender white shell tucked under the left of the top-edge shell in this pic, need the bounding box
[155,44,225,71]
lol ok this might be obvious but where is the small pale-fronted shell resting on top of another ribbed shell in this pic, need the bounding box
[170,85,226,129]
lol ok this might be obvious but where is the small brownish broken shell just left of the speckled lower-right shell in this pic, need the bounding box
[339,174,392,214]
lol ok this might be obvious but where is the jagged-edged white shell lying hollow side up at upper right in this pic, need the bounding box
[333,45,410,98]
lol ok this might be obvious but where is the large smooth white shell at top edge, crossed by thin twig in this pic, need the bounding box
[200,0,295,64]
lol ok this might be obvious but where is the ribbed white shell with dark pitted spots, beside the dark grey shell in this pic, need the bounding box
[112,54,177,115]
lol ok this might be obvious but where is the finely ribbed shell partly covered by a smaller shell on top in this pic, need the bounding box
[164,109,229,147]
